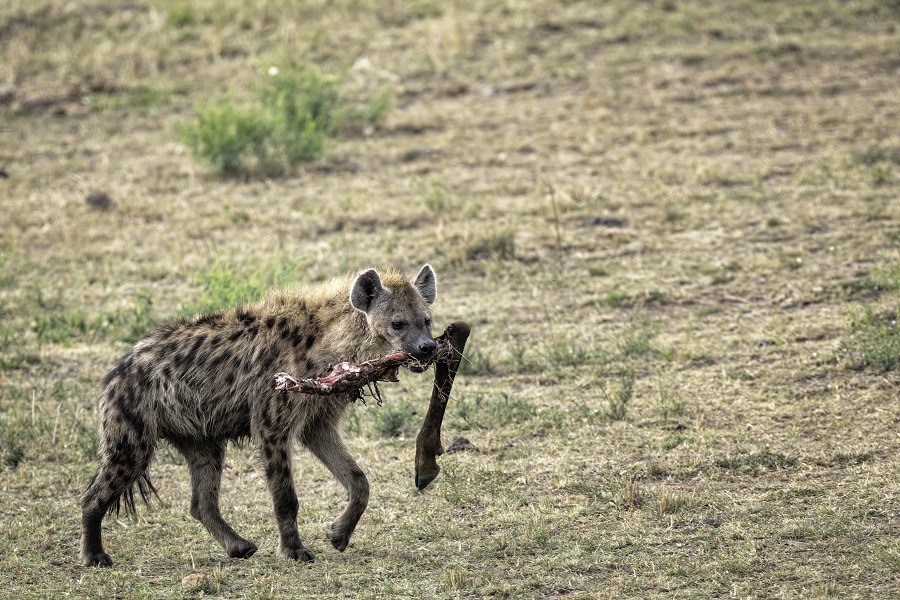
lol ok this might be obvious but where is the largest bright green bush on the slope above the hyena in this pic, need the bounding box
[179,66,393,176]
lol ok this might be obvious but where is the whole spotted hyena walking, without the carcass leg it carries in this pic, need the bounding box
[81,265,437,565]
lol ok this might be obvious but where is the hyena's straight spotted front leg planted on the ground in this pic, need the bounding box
[262,434,316,562]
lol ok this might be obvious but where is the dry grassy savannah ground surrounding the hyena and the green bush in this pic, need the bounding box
[0,0,900,598]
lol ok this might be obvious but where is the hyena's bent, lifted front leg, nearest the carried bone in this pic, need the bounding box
[302,423,369,552]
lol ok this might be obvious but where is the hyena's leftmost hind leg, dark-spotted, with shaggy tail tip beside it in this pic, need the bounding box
[81,429,156,567]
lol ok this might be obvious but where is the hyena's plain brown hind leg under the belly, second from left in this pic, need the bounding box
[175,440,257,558]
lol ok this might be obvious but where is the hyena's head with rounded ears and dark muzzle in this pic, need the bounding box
[350,265,437,360]
